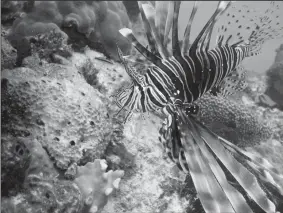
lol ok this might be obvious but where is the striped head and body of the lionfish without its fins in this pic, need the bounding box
[116,45,248,116]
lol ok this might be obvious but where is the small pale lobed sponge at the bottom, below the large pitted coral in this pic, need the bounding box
[74,159,124,213]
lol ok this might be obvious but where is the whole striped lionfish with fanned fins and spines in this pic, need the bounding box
[113,1,283,213]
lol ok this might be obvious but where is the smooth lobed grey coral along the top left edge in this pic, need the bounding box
[10,1,131,58]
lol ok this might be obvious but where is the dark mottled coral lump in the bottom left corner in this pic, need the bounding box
[1,177,82,213]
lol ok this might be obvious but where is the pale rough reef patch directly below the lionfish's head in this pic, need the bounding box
[102,115,191,213]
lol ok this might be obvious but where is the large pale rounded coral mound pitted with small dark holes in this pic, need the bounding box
[2,60,121,170]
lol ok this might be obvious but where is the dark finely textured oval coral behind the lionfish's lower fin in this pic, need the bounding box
[196,95,272,146]
